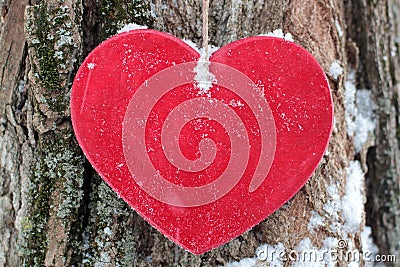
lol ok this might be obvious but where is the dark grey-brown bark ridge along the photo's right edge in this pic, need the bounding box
[346,1,400,254]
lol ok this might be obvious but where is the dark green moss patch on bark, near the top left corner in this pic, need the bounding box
[26,1,78,113]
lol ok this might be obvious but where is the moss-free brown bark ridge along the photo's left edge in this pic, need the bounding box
[0,0,32,266]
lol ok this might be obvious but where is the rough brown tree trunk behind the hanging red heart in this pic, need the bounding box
[0,0,400,266]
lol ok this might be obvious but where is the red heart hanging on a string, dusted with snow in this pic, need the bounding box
[71,30,333,254]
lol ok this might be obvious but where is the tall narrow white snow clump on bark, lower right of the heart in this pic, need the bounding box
[342,161,365,233]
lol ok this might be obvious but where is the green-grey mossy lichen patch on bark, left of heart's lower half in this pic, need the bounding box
[21,131,83,266]
